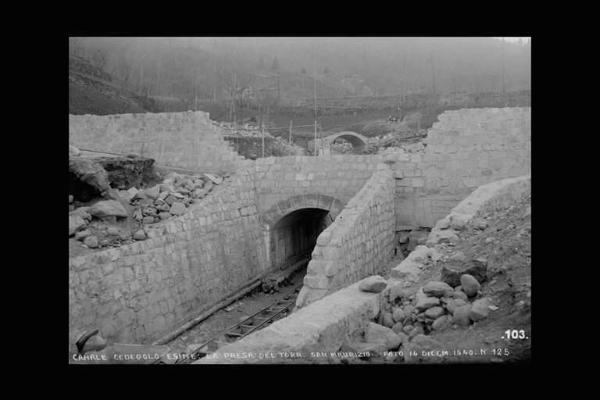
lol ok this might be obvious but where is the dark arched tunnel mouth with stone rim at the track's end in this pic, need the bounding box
[260,193,344,269]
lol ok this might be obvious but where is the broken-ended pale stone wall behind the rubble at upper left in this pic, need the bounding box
[69,111,243,173]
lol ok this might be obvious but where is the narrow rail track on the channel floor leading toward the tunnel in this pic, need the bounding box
[157,294,296,364]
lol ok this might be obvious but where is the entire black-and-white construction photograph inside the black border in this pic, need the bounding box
[68,35,537,368]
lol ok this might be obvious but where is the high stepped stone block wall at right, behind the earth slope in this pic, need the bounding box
[386,107,531,228]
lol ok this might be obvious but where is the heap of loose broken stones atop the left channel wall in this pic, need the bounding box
[123,173,224,224]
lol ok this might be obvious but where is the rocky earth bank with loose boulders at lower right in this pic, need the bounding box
[306,193,531,364]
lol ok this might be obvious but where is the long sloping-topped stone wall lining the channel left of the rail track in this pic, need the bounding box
[69,162,267,343]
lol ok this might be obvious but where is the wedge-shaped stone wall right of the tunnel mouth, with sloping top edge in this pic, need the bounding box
[296,164,395,307]
